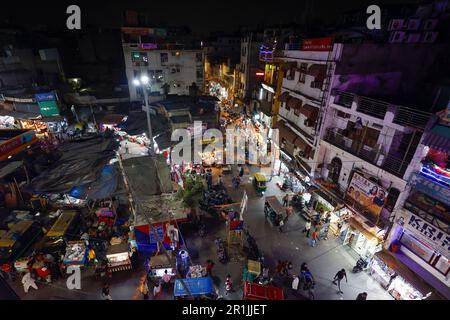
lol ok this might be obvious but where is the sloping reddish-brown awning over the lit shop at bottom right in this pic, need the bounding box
[375,250,434,295]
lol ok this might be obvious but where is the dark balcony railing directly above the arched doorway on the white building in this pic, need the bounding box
[325,128,378,165]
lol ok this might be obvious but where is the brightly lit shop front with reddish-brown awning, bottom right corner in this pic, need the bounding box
[370,250,433,300]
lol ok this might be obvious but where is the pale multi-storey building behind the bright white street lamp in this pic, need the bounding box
[122,27,204,101]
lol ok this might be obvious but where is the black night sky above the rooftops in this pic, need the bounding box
[0,0,419,34]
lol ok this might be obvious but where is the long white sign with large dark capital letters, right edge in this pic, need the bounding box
[396,210,450,258]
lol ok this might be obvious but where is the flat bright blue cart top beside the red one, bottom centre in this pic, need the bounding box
[173,277,215,299]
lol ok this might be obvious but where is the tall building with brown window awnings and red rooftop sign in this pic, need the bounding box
[276,38,339,176]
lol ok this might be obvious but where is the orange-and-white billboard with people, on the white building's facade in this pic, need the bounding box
[347,172,387,216]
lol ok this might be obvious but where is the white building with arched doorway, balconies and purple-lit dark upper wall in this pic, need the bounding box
[306,44,448,299]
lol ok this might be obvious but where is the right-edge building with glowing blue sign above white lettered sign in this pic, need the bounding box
[386,108,450,299]
